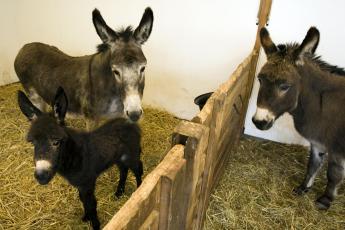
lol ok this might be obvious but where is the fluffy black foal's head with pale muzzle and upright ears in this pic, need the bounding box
[18,87,68,185]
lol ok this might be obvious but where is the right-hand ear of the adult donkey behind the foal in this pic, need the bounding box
[134,7,153,44]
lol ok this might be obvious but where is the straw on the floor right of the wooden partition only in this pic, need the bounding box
[205,137,345,230]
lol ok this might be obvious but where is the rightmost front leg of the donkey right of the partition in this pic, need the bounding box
[316,154,345,209]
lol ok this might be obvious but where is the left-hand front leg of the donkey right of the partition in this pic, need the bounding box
[294,146,326,195]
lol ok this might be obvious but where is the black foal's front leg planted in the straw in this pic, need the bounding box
[78,185,100,229]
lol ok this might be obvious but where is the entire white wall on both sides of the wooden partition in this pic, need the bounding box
[0,0,345,143]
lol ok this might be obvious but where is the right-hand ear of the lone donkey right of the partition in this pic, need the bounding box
[297,27,320,62]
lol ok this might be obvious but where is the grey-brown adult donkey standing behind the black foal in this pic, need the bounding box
[14,8,153,122]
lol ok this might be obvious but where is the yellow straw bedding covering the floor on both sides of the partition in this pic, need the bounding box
[0,84,345,230]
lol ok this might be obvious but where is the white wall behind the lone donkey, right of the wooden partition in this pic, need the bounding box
[245,0,345,144]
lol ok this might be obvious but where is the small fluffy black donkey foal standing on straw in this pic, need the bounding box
[18,87,143,229]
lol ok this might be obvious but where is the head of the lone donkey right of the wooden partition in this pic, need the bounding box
[252,27,320,130]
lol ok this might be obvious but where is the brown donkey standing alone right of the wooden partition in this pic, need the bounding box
[252,27,345,209]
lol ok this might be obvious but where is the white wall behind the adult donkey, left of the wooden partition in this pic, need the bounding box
[0,0,259,118]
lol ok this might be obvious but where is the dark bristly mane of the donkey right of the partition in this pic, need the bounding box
[277,43,345,76]
